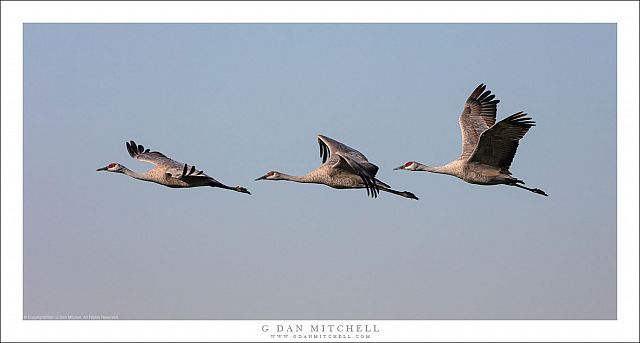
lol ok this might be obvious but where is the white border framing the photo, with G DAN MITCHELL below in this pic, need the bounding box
[1,2,639,341]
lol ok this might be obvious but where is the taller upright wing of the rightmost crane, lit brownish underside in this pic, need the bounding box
[460,83,500,158]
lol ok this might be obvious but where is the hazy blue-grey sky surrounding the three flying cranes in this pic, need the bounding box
[24,24,616,319]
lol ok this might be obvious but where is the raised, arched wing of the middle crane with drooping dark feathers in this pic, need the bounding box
[318,135,379,198]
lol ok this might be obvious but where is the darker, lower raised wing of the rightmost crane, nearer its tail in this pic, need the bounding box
[469,112,535,173]
